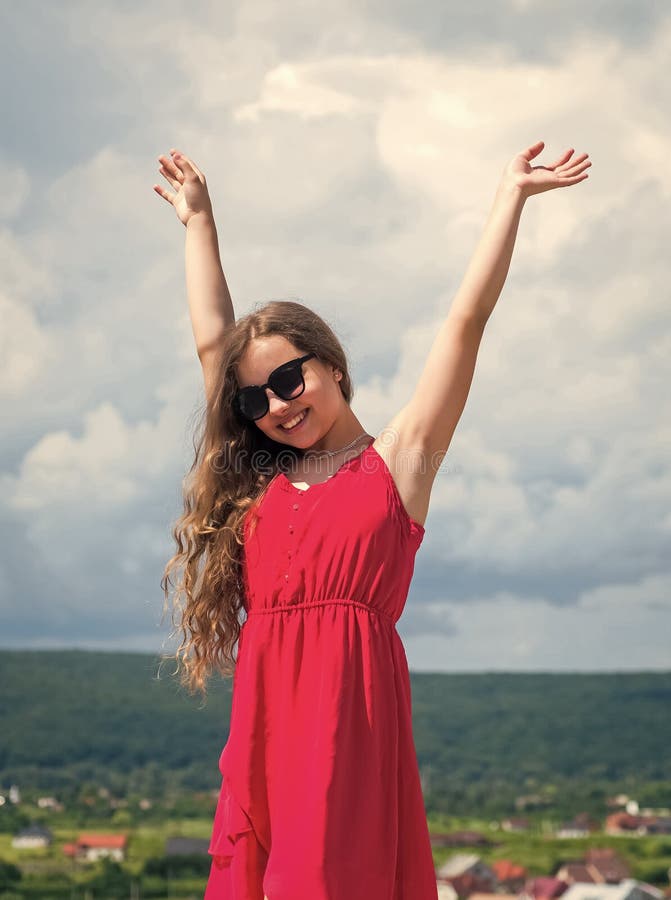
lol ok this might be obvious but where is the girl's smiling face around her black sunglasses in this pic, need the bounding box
[236,334,346,450]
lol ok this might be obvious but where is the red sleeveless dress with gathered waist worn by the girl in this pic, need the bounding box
[204,443,438,900]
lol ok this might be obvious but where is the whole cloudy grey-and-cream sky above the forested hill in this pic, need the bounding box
[0,0,671,671]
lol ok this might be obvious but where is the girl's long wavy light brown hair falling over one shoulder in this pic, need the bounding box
[161,300,353,696]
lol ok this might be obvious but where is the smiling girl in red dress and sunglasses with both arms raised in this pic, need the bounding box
[154,141,591,900]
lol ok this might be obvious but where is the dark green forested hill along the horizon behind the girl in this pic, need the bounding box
[0,650,671,814]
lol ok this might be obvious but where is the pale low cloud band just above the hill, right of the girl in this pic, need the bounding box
[399,576,671,672]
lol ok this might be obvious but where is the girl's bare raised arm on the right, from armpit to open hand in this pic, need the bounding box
[380,141,591,522]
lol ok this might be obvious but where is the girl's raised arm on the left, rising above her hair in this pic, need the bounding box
[154,150,235,396]
